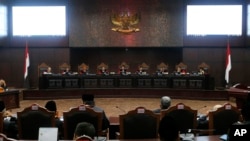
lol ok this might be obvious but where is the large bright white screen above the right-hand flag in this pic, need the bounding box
[186,5,243,36]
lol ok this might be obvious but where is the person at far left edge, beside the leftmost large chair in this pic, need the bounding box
[0,101,18,139]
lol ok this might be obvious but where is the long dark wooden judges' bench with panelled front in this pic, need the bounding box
[39,74,214,89]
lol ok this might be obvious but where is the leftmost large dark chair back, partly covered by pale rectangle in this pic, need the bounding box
[17,104,55,140]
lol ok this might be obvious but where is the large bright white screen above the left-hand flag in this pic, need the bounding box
[12,6,66,36]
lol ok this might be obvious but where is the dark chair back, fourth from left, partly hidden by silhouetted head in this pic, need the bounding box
[161,103,197,133]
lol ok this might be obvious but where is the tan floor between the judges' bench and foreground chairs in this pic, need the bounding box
[11,98,236,117]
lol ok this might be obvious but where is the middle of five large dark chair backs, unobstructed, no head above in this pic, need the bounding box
[119,107,160,139]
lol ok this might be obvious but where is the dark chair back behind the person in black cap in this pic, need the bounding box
[63,105,102,140]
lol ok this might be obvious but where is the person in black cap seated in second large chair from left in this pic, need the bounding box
[82,94,110,131]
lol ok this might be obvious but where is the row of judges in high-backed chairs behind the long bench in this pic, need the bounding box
[38,62,209,75]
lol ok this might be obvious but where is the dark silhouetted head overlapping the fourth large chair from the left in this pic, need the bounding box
[158,115,180,141]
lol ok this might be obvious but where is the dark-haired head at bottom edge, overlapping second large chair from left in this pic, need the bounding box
[74,122,96,140]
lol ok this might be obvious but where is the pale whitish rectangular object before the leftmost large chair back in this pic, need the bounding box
[38,127,58,141]
